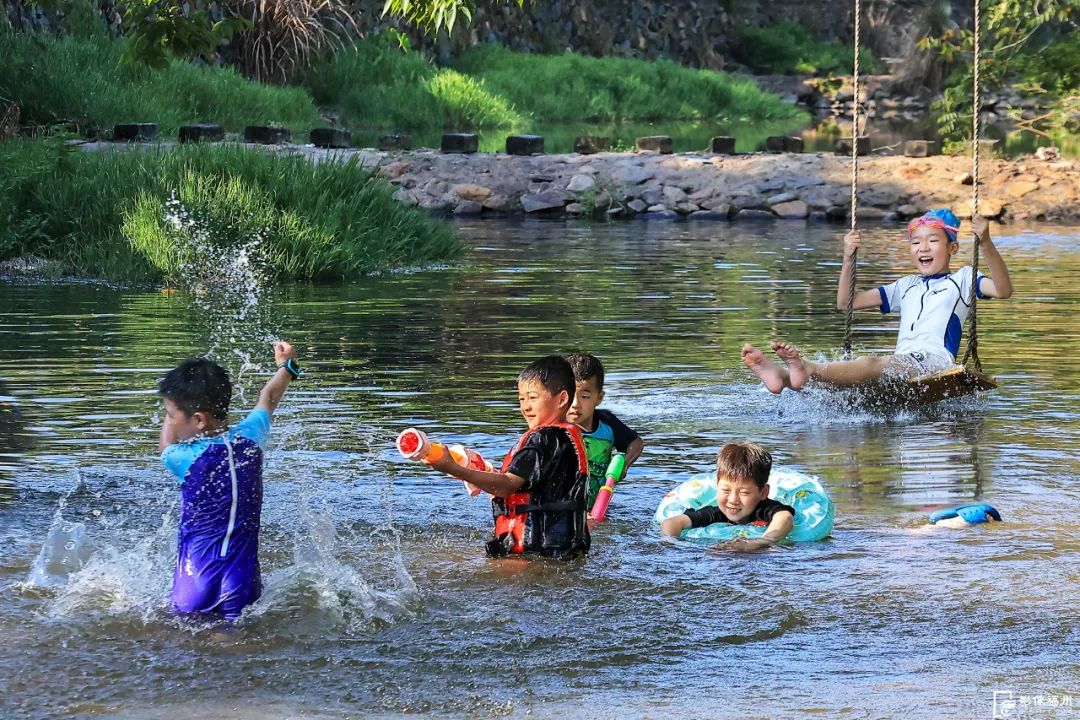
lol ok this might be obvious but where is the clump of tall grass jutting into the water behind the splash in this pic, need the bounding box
[0,140,461,281]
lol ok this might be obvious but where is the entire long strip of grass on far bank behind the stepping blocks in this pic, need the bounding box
[0,32,806,138]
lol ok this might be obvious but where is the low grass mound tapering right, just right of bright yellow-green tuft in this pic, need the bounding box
[456,45,805,122]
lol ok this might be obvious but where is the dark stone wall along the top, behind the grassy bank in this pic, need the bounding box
[6,0,946,69]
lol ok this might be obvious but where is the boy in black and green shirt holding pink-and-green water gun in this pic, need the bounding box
[566,353,645,520]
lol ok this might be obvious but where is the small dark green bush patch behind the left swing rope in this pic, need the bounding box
[731,23,878,74]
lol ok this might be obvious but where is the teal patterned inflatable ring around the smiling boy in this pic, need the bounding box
[652,467,836,543]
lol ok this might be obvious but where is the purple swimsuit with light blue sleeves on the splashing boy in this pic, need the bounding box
[161,409,270,621]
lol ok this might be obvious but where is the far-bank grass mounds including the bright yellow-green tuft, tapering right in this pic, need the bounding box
[305,38,806,128]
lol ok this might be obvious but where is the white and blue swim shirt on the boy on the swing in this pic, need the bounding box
[878,266,988,365]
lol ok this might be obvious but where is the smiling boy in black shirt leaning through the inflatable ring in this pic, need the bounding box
[660,443,795,551]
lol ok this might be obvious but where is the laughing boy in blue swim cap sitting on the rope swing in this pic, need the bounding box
[742,209,1013,393]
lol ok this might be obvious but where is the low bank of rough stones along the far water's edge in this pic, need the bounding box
[368,151,1080,222]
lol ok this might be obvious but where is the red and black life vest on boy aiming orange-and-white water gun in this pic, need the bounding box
[487,422,590,557]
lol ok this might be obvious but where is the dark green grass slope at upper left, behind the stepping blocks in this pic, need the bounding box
[0,32,319,137]
